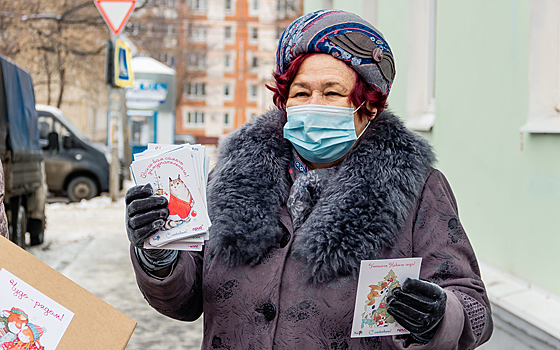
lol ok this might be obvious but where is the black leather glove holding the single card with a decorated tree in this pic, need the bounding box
[387,278,447,344]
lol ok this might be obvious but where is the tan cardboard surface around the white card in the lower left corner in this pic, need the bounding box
[0,237,136,350]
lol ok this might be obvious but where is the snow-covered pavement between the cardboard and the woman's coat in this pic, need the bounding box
[29,190,202,350]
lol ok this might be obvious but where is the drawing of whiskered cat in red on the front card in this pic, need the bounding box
[162,175,194,230]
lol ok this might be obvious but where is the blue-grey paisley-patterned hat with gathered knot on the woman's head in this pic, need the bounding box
[276,10,396,95]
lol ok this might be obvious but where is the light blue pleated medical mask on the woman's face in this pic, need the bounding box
[284,103,369,164]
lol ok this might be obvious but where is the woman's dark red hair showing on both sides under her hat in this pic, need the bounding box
[266,53,387,118]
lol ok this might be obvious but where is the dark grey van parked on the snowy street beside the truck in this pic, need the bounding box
[35,104,124,202]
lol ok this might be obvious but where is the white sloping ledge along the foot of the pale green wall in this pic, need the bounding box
[479,261,560,339]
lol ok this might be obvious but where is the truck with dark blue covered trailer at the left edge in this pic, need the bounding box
[0,54,47,247]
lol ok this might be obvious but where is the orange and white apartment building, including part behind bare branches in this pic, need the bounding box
[126,0,303,143]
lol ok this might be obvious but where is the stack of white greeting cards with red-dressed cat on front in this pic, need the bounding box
[130,144,212,251]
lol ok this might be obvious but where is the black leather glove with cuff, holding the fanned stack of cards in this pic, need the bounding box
[125,184,178,273]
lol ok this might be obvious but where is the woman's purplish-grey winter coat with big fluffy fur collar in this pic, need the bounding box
[132,110,492,350]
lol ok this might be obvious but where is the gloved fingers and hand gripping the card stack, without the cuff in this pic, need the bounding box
[125,184,169,248]
